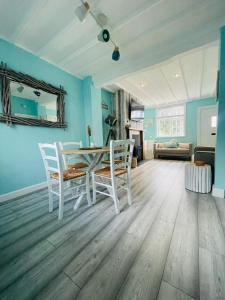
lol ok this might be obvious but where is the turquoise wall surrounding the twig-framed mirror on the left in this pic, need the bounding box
[0,39,85,194]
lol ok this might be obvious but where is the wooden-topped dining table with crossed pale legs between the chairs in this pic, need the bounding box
[61,147,110,209]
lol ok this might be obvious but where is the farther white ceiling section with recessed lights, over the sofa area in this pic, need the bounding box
[113,42,219,107]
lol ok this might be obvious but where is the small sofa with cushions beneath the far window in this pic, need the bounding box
[154,141,192,160]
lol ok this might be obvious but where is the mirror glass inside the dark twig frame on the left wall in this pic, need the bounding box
[10,81,57,122]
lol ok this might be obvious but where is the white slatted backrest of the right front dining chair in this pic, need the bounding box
[110,139,135,177]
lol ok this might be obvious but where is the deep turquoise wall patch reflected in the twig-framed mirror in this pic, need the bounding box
[11,96,38,116]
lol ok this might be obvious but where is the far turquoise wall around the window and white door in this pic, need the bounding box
[144,98,216,148]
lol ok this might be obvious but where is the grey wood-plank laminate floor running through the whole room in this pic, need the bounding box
[0,160,225,300]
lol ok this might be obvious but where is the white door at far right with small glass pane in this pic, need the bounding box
[197,105,217,147]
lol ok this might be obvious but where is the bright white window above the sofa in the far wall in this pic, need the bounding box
[156,105,185,137]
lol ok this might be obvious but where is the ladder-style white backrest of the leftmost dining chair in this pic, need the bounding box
[38,143,63,181]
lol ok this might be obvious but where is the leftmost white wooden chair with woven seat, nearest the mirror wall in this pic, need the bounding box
[38,143,91,220]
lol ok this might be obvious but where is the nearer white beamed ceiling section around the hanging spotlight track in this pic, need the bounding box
[0,0,225,106]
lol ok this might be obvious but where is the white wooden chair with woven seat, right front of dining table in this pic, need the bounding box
[92,140,134,214]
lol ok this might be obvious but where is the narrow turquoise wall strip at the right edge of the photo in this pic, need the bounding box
[215,26,225,190]
